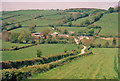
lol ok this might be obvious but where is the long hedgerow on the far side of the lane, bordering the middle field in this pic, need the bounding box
[0,50,80,69]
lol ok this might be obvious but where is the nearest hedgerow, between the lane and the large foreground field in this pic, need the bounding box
[2,52,92,81]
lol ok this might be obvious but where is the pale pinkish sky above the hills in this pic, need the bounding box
[2,0,118,11]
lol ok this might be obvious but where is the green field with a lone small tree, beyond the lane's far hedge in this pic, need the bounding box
[2,44,76,61]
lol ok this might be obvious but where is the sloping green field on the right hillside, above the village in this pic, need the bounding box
[94,13,118,36]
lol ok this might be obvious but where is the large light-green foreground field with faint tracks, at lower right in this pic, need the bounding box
[30,48,118,79]
